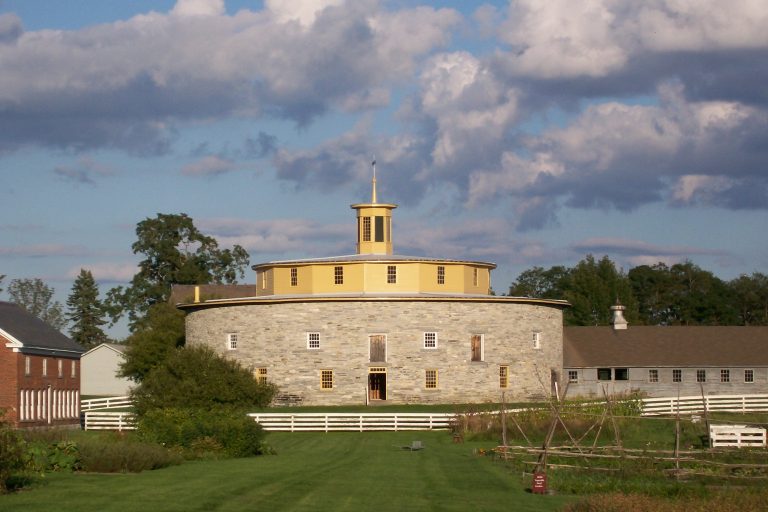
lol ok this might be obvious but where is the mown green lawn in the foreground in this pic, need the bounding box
[0,432,573,512]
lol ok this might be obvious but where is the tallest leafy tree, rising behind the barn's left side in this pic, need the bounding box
[107,213,248,330]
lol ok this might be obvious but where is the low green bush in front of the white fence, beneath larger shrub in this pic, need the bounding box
[137,408,265,457]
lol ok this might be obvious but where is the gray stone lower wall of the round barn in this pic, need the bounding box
[186,298,563,405]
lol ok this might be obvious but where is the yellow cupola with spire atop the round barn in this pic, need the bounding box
[351,160,397,254]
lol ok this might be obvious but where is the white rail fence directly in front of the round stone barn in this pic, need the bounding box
[248,413,455,432]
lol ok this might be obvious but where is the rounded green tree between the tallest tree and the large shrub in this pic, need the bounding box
[120,302,184,382]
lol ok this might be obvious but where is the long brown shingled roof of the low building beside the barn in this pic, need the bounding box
[563,325,768,368]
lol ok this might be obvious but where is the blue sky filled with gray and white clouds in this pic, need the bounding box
[0,0,768,337]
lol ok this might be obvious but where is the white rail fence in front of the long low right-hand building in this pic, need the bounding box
[643,394,768,416]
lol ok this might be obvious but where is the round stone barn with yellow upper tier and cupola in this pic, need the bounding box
[179,177,568,405]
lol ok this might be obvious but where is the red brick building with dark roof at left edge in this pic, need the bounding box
[0,301,84,427]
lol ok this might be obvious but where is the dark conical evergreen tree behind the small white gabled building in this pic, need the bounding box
[67,268,108,349]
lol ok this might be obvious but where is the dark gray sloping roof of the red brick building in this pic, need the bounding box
[0,301,85,356]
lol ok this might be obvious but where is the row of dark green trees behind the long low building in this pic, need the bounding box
[509,254,768,325]
